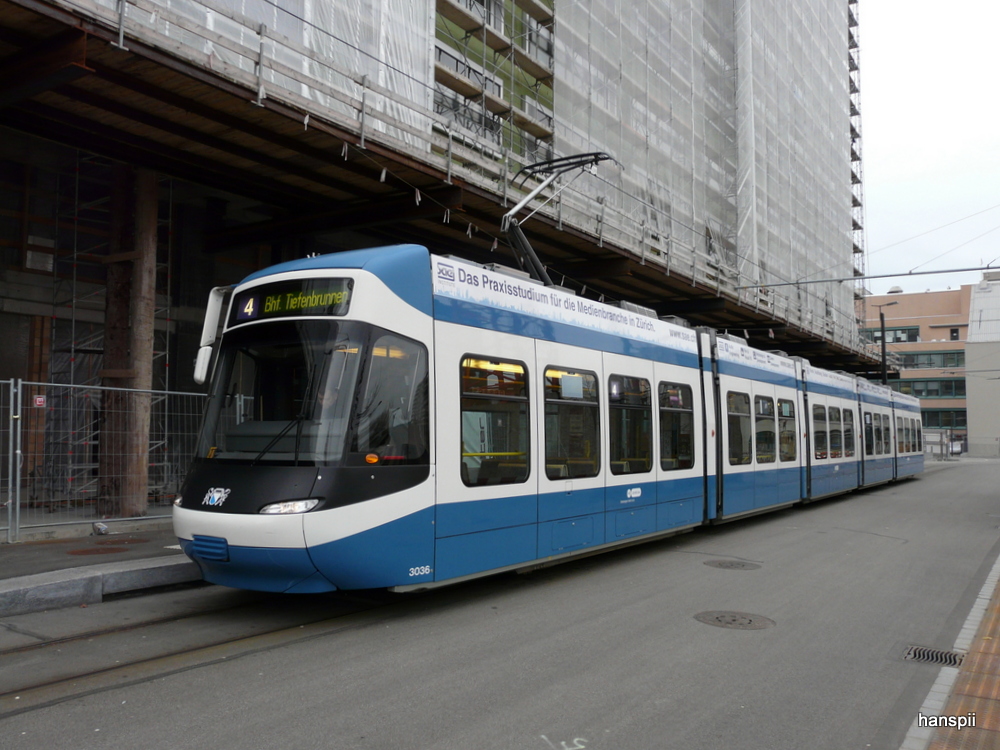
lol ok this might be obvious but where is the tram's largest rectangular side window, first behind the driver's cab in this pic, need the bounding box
[461,355,531,487]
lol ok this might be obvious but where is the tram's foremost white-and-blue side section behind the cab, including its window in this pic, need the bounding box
[435,321,540,580]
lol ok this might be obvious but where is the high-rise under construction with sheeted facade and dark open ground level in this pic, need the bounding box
[0,0,877,532]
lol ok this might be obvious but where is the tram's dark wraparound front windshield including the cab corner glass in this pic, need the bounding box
[198,320,427,465]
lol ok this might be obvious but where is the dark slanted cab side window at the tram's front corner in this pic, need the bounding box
[351,334,430,465]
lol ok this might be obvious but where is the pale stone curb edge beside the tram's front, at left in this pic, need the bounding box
[0,555,202,617]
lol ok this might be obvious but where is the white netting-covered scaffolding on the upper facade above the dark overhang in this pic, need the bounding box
[7,0,864,352]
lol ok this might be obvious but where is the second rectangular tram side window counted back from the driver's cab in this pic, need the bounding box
[545,367,601,479]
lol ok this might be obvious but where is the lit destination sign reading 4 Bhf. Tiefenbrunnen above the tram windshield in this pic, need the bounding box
[229,279,354,326]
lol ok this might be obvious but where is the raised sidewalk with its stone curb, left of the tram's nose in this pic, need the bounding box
[0,518,201,617]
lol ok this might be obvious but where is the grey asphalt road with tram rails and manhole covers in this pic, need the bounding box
[0,461,1000,750]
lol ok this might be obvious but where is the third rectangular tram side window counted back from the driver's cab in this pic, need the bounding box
[608,375,653,474]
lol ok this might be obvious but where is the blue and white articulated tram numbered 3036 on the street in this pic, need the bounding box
[174,245,921,592]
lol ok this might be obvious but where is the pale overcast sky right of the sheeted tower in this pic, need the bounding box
[859,0,1000,294]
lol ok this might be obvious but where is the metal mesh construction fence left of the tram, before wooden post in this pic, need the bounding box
[0,380,205,542]
